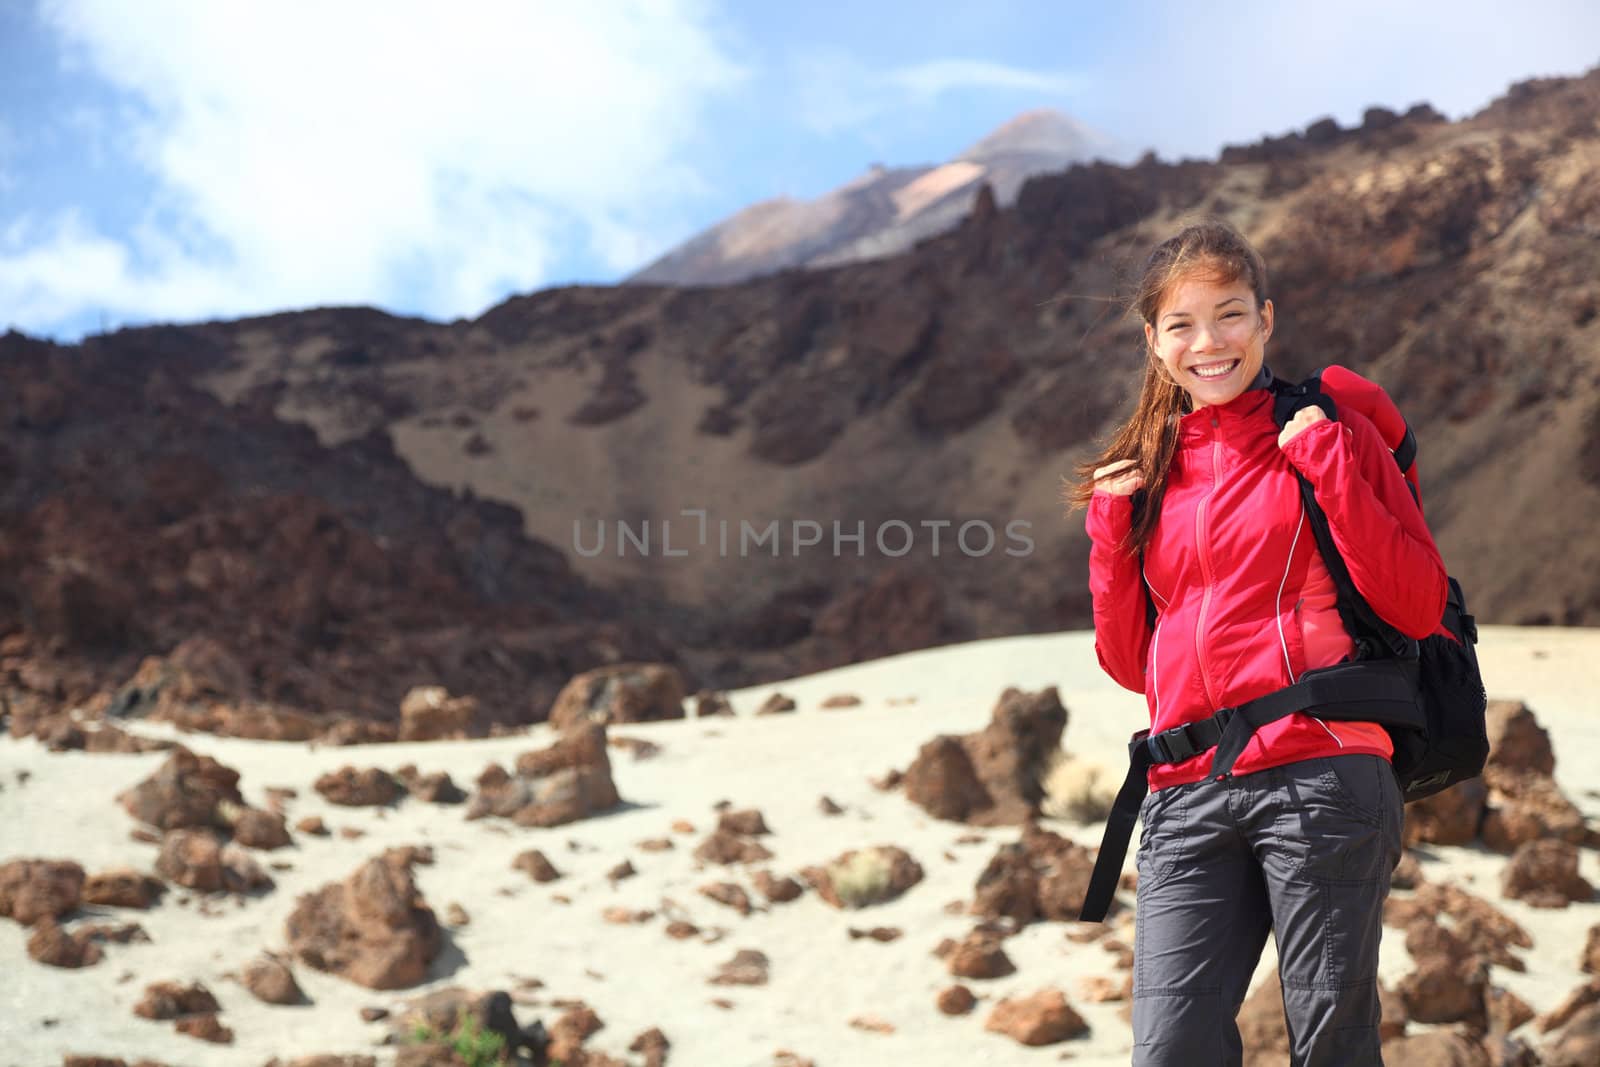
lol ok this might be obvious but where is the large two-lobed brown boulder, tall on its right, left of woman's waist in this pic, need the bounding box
[906,686,1067,825]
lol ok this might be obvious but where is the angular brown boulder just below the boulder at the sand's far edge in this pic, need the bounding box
[467,725,621,827]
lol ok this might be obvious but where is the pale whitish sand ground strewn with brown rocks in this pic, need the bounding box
[0,627,1600,1067]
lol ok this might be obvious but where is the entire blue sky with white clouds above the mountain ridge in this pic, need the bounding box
[0,0,1600,339]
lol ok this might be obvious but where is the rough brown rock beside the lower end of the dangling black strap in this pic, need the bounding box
[971,822,1120,923]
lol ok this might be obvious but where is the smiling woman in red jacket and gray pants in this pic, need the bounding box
[1072,222,1446,1067]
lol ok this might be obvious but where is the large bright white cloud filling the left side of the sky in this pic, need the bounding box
[0,0,746,337]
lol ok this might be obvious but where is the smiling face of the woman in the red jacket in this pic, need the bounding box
[1144,275,1272,408]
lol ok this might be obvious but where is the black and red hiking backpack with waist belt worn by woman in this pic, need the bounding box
[1078,366,1490,921]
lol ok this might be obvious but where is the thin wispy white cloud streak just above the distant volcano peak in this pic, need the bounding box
[790,51,1085,134]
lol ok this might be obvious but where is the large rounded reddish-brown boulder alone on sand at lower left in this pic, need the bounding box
[286,857,440,989]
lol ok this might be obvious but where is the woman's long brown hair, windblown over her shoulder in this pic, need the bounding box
[1064,219,1267,552]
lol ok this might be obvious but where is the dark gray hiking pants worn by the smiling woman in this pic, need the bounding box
[1133,755,1403,1067]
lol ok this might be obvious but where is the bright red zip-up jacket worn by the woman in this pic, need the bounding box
[1088,379,1448,789]
